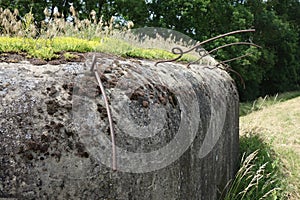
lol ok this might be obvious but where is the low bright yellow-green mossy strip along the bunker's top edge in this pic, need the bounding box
[0,37,200,61]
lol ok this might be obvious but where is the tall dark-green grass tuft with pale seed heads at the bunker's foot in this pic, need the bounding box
[224,135,287,200]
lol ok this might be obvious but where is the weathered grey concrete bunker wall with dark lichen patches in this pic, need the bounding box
[0,54,239,200]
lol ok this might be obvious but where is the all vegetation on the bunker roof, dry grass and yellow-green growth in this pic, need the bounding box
[0,6,217,65]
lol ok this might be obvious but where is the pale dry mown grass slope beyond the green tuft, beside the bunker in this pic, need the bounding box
[240,97,300,199]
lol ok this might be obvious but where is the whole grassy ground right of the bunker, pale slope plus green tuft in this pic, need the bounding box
[236,92,300,200]
